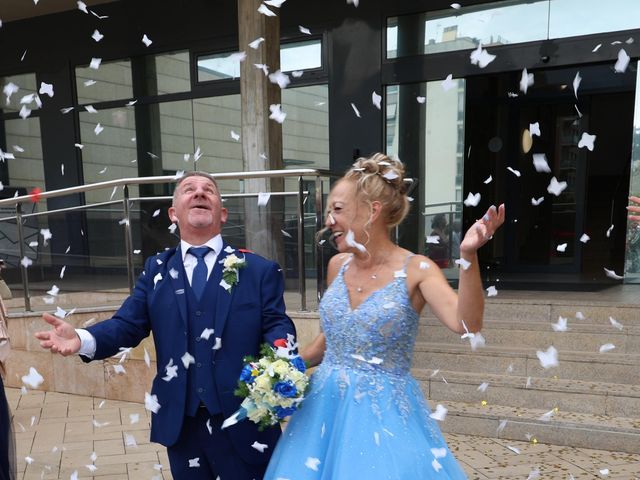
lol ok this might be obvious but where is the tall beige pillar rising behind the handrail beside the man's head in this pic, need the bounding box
[238,0,284,265]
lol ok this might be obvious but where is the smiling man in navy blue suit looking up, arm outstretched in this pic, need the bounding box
[36,172,295,480]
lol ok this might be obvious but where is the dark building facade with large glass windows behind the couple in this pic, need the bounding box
[0,0,640,289]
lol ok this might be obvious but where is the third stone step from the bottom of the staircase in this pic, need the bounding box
[413,341,640,384]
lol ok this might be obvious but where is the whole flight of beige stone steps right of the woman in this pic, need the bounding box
[413,295,640,453]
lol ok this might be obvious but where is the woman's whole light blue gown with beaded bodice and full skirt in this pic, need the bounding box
[264,259,467,480]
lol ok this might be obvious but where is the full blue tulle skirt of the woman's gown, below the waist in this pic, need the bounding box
[264,364,467,480]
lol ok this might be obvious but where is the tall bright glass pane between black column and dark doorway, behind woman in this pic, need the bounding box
[386,79,465,278]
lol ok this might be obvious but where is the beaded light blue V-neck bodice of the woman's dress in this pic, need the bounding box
[314,257,419,416]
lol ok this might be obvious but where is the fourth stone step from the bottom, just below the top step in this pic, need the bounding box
[418,319,640,353]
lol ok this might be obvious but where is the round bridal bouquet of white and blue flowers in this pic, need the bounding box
[222,335,309,430]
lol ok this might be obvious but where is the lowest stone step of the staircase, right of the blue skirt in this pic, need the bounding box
[431,401,640,453]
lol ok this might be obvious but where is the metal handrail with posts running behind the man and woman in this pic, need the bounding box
[0,168,338,311]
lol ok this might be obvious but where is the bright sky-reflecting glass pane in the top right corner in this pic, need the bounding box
[549,0,640,41]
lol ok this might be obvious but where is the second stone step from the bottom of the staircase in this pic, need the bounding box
[412,368,640,417]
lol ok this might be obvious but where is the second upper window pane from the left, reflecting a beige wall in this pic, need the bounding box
[76,60,133,104]
